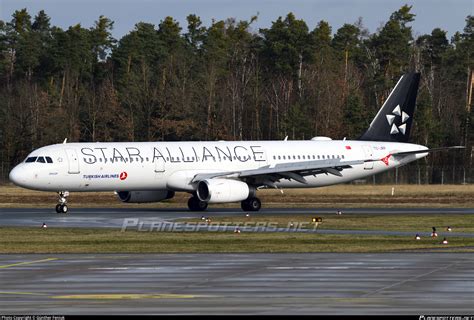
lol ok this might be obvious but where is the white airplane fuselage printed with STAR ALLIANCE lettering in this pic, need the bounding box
[10,140,427,192]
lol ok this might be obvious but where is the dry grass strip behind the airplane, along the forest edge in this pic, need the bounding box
[0,185,474,208]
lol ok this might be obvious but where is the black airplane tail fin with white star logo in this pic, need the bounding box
[358,72,420,142]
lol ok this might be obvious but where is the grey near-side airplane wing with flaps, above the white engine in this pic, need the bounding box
[191,159,364,187]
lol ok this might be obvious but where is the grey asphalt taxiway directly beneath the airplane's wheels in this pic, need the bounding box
[0,208,474,238]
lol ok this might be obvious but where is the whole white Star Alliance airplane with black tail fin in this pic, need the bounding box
[9,72,463,213]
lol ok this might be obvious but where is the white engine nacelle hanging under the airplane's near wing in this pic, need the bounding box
[197,179,250,203]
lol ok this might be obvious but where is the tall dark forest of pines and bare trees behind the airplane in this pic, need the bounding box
[0,5,474,182]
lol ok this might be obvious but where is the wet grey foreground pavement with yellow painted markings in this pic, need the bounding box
[0,253,474,315]
